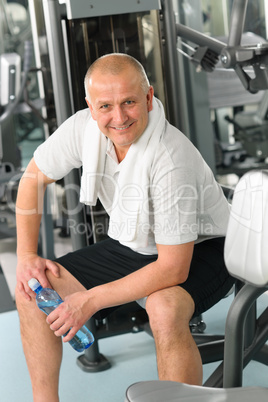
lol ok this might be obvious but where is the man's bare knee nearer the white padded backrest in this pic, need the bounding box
[146,286,195,333]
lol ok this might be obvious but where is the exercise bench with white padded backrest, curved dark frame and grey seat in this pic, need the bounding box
[125,170,268,402]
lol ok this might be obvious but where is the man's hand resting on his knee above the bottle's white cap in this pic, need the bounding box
[17,254,59,301]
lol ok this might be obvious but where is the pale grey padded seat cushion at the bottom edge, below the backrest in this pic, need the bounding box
[125,381,268,402]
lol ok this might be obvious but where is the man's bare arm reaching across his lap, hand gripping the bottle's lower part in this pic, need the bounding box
[47,242,194,342]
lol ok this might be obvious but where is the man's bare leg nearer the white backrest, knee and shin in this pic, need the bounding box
[146,286,203,385]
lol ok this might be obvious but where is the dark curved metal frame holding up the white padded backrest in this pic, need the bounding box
[199,284,268,388]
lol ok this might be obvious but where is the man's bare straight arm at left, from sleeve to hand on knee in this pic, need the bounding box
[16,159,58,300]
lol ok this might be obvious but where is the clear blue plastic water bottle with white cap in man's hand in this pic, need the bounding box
[28,278,94,352]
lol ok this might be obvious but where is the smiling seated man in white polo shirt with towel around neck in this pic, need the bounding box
[16,54,233,402]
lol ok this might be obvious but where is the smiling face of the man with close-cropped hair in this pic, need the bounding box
[86,66,153,161]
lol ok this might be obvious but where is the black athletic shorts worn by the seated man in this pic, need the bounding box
[55,237,235,319]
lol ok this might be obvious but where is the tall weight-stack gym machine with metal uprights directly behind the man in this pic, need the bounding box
[38,0,216,372]
